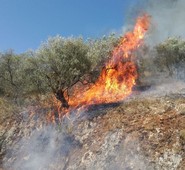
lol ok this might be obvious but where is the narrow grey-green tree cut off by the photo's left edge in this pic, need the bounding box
[0,50,25,98]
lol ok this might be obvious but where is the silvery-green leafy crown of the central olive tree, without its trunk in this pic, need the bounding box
[35,35,117,92]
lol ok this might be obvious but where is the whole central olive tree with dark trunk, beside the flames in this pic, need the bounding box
[35,36,91,108]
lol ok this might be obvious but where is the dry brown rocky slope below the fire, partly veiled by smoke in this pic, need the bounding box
[0,90,185,170]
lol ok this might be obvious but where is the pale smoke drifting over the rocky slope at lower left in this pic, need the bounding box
[4,126,80,170]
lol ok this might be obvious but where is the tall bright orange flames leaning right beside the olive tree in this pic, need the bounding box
[64,15,149,112]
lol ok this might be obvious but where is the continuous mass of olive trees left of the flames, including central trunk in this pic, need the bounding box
[0,35,118,108]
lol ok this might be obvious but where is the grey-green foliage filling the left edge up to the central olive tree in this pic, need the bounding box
[0,51,44,100]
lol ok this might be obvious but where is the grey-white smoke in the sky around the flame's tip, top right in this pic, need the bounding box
[122,0,185,46]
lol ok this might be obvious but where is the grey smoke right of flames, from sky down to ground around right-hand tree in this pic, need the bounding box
[123,0,185,92]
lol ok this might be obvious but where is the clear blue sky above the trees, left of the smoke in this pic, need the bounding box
[0,0,136,53]
